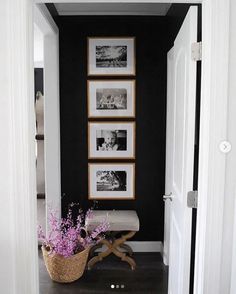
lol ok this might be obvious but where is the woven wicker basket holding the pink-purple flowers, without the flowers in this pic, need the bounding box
[42,246,90,283]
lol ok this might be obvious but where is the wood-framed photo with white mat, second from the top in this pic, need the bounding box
[87,80,135,118]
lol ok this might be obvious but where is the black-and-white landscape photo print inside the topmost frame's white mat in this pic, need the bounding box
[96,46,127,68]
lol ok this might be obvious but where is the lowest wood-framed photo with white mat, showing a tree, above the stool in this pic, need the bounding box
[88,163,135,200]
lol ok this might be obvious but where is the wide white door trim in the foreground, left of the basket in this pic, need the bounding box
[0,0,39,294]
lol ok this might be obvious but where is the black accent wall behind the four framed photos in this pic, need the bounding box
[58,16,169,241]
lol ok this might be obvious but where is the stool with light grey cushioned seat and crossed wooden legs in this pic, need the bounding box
[86,210,139,270]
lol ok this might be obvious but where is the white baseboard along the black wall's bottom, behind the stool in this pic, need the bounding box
[96,241,163,253]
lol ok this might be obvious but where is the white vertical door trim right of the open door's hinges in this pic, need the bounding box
[194,0,229,294]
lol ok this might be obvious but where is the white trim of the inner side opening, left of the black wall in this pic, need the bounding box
[34,4,61,229]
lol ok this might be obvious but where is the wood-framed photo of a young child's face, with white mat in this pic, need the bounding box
[88,122,135,159]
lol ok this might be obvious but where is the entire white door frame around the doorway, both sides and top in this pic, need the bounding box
[0,0,230,294]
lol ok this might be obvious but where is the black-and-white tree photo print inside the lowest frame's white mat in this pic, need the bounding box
[96,170,127,191]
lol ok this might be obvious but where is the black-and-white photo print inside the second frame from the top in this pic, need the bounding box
[96,88,127,110]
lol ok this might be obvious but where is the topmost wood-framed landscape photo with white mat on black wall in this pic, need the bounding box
[88,37,135,75]
